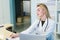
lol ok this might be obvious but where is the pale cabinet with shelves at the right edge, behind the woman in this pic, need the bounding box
[56,0,60,34]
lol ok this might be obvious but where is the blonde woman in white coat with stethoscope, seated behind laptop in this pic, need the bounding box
[11,3,55,40]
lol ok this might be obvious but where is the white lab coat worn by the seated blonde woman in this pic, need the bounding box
[21,18,55,40]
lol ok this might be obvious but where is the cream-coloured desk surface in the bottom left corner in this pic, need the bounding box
[0,24,13,40]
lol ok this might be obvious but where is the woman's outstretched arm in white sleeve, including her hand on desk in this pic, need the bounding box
[10,21,37,38]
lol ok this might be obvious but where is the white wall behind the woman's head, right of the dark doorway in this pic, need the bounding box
[31,0,56,23]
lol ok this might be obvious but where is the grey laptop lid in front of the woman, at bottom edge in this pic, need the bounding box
[20,34,46,40]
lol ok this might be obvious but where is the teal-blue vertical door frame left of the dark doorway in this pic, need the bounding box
[10,0,16,29]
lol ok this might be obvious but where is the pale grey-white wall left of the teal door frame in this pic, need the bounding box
[0,0,11,25]
